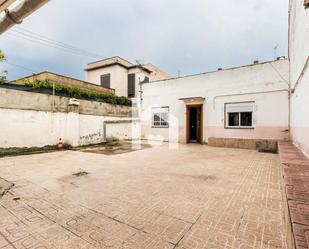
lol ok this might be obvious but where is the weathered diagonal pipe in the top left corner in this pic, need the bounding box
[0,0,49,34]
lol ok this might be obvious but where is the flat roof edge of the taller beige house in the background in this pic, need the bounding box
[85,56,152,73]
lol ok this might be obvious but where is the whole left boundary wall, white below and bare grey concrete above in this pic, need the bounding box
[0,88,132,148]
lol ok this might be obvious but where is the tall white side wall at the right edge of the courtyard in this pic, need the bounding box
[289,0,309,155]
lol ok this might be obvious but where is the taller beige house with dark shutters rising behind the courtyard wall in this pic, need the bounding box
[85,56,171,98]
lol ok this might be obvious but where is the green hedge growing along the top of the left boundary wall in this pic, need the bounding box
[23,80,132,106]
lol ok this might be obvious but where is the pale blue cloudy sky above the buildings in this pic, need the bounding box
[0,0,288,79]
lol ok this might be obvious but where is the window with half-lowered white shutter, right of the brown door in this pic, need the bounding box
[225,102,254,129]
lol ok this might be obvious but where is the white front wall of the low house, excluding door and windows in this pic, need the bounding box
[142,60,289,142]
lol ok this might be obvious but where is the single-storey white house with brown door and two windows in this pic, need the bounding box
[141,58,289,143]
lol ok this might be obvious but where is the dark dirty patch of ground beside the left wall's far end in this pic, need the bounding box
[74,141,151,155]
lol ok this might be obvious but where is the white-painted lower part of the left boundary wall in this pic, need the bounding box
[0,108,132,148]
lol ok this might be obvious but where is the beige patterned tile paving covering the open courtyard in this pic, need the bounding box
[0,145,288,249]
